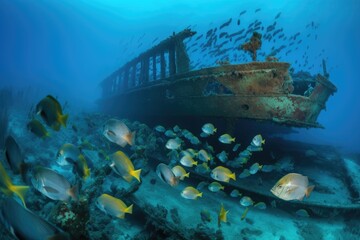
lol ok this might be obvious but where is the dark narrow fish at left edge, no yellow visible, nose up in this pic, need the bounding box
[4,136,26,174]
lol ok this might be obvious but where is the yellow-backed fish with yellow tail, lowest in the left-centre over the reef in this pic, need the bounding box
[96,194,133,219]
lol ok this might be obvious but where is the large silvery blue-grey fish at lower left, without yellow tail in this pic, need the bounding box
[31,167,78,201]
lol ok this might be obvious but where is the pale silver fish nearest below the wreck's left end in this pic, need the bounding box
[103,118,135,147]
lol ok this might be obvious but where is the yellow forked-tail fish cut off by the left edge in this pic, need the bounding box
[0,163,29,206]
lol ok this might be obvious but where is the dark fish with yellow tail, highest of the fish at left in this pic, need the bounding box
[36,95,68,131]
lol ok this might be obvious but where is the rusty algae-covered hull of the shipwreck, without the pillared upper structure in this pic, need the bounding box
[100,62,336,127]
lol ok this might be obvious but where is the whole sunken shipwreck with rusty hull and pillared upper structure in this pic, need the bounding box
[98,29,336,128]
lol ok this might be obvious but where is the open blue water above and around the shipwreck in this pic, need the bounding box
[0,0,360,239]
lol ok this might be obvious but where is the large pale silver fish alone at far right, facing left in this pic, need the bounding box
[270,173,315,201]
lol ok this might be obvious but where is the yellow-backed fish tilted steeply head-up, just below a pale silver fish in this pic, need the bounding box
[110,151,141,182]
